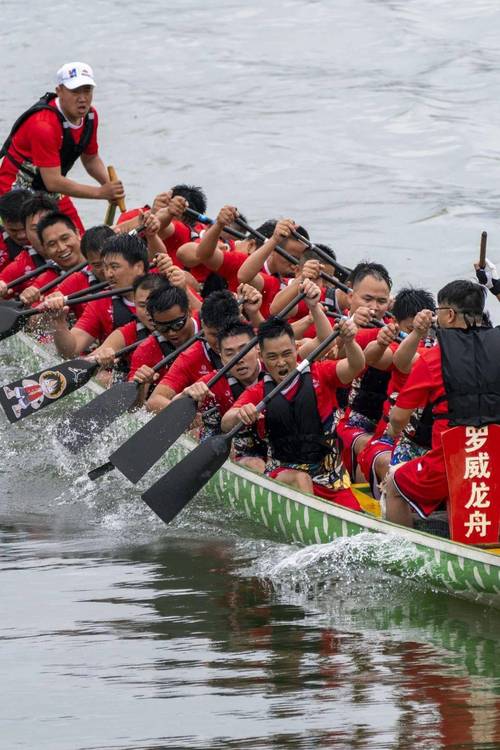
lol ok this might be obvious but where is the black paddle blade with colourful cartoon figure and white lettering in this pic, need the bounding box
[0,359,97,422]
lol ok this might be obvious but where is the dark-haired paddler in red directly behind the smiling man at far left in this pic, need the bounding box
[0,192,57,297]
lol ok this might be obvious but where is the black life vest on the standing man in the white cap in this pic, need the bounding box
[0,91,95,192]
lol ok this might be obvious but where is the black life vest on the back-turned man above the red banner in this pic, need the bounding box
[433,326,500,427]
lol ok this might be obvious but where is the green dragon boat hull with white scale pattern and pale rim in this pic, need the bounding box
[3,333,500,607]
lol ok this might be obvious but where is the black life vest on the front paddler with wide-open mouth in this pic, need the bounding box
[264,371,329,464]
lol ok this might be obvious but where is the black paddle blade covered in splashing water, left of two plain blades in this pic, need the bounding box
[57,383,137,453]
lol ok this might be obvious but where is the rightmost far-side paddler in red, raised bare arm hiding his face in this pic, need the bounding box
[238,219,309,318]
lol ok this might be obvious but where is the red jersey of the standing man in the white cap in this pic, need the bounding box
[0,100,99,195]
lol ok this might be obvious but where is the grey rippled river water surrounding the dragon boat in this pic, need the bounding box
[0,0,500,750]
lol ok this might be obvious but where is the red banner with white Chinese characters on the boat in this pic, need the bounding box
[442,425,500,544]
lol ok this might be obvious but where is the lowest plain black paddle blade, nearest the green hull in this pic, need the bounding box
[142,435,231,523]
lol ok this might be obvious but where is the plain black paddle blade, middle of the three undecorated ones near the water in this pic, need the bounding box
[109,397,196,484]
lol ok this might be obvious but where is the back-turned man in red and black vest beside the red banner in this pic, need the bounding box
[385,280,500,526]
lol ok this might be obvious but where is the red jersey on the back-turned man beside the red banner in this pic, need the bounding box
[396,345,448,451]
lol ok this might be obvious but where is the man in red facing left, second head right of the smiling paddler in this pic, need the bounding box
[43,234,148,359]
